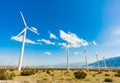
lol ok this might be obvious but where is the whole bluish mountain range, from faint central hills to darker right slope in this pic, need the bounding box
[48,56,120,68]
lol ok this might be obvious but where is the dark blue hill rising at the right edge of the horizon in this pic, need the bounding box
[89,56,120,67]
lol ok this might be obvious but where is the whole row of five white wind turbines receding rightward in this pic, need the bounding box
[16,11,107,72]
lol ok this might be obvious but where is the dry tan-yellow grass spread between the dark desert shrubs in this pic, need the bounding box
[0,69,120,83]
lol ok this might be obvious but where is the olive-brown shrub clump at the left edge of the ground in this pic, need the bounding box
[0,70,15,80]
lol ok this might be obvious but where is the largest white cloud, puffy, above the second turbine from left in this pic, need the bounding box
[60,30,88,48]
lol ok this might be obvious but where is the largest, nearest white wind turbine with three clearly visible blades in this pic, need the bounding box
[16,11,39,71]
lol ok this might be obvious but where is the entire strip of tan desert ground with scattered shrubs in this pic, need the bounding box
[0,68,120,83]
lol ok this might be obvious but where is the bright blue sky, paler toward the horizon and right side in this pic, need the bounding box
[0,0,120,65]
